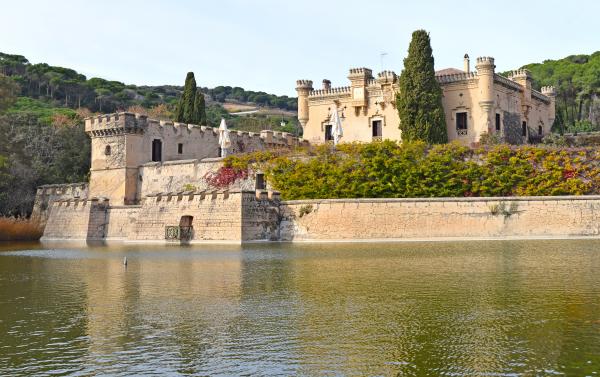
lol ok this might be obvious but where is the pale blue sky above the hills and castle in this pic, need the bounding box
[0,0,600,95]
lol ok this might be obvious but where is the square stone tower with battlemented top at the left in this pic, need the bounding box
[85,113,146,205]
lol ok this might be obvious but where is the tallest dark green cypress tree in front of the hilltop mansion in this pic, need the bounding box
[396,30,448,144]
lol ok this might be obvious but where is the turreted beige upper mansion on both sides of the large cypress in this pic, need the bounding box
[296,55,556,145]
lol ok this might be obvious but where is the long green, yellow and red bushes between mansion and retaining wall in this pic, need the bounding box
[218,141,600,200]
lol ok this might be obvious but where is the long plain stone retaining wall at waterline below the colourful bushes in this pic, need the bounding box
[279,196,600,241]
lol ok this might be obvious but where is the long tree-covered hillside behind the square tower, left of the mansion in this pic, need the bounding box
[0,52,297,113]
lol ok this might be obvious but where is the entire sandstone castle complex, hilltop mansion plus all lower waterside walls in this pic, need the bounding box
[32,55,564,243]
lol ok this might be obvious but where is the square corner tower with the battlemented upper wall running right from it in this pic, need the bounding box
[85,113,302,205]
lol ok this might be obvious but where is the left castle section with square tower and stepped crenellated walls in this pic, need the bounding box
[32,112,303,242]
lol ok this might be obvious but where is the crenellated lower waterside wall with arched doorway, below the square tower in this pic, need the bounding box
[42,190,279,243]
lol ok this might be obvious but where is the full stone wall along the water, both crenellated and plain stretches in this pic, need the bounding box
[43,190,600,243]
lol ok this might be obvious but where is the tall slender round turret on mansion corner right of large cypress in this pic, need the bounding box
[474,56,496,142]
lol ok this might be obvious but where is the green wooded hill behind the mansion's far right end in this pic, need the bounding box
[524,51,600,132]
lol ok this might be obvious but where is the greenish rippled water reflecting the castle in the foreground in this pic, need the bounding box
[0,241,600,376]
